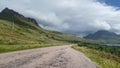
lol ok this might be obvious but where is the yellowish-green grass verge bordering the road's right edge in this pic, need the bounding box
[72,45,120,68]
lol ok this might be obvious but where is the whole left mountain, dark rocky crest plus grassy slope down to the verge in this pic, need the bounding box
[0,8,88,44]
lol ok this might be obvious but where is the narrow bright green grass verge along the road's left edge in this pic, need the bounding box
[0,43,64,53]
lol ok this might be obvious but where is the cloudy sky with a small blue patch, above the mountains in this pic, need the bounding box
[0,0,120,36]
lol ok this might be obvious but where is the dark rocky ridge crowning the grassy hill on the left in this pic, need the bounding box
[0,8,39,26]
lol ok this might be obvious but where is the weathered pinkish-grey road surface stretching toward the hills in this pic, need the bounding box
[0,46,99,68]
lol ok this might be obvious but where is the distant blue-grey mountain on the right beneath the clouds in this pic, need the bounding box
[84,30,120,43]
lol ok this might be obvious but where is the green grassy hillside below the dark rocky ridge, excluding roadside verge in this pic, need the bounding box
[0,20,86,44]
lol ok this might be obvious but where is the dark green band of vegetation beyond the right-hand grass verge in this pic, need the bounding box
[78,43,120,57]
